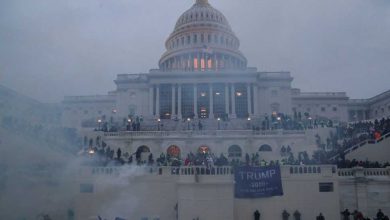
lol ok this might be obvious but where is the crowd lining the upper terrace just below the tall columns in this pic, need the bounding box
[90,112,333,132]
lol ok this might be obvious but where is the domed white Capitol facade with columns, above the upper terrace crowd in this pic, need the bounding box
[63,1,390,127]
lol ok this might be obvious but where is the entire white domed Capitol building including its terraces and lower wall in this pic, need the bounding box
[57,0,390,220]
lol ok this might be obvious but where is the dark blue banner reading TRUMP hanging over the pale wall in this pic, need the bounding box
[234,166,283,198]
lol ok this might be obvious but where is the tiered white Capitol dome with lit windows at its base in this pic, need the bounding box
[159,0,247,72]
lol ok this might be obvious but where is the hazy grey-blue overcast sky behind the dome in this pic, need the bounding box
[0,0,390,102]
